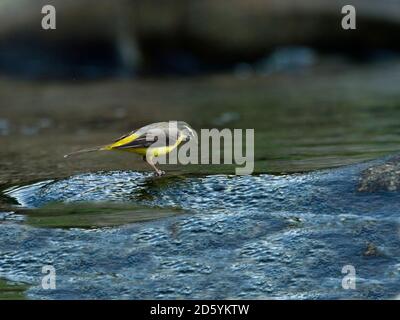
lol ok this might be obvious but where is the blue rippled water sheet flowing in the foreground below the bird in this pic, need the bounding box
[0,158,400,299]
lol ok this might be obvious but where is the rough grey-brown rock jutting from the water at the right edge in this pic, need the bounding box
[358,156,400,192]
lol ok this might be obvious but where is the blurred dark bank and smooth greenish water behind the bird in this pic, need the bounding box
[0,0,400,185]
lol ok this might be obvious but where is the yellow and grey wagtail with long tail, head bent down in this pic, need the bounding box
[64,121,197,176]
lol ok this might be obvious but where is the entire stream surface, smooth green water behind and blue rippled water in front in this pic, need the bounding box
[0,63,400,299]
